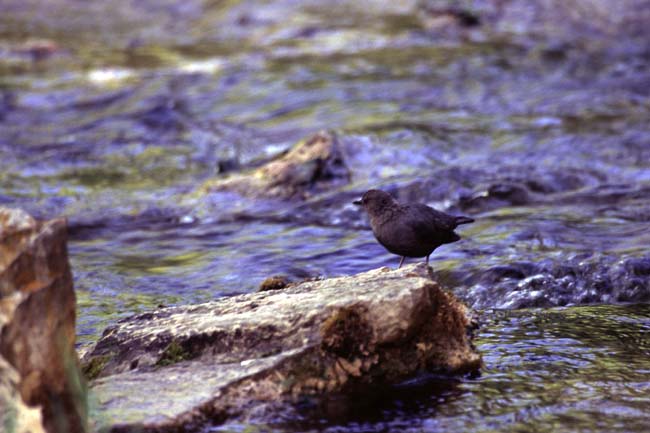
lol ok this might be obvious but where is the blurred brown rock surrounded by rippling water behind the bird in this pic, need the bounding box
[199,131,350,199]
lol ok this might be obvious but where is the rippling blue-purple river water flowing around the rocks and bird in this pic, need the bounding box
[0,0,650,432]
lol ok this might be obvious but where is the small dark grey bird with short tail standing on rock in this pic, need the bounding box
[354,189,474,268]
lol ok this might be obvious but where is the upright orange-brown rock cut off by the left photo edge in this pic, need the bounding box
[0,207,87,433]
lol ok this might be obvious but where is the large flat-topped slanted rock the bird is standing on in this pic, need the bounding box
[83,264,481,432]
